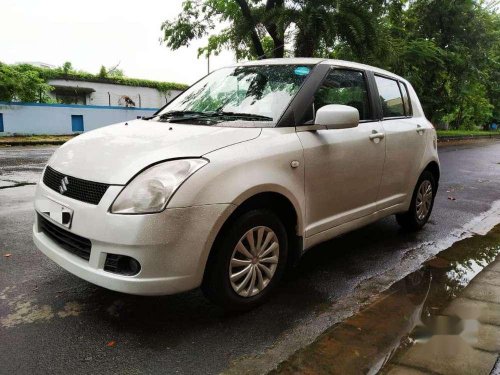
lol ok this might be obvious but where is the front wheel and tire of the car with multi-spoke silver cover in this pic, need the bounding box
[201,209,288,311]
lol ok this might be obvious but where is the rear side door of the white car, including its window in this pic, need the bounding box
[375,74,427,209]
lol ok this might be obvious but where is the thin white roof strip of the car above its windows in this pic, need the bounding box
[235,57,406,81]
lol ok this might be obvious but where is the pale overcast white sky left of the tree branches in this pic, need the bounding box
[0,0,235,84]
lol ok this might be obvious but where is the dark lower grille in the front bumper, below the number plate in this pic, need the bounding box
[38,214,92,261]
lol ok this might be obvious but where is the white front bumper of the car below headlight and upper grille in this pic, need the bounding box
[33,182,235,295]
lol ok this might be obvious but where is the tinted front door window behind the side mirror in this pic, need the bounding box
[314,69,372,120]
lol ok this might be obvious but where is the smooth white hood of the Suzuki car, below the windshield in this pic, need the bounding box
[48,120,261,185]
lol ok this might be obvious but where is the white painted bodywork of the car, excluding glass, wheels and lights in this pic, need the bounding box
[33,59,439,295]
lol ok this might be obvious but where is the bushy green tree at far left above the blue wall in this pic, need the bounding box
[0,63,52,103]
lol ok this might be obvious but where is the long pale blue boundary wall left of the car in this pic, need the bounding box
[0,102,157,135]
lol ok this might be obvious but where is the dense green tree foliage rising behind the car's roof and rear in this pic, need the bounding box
[162,0,500,128]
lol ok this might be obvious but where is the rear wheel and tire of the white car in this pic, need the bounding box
[396,171,437,231]
